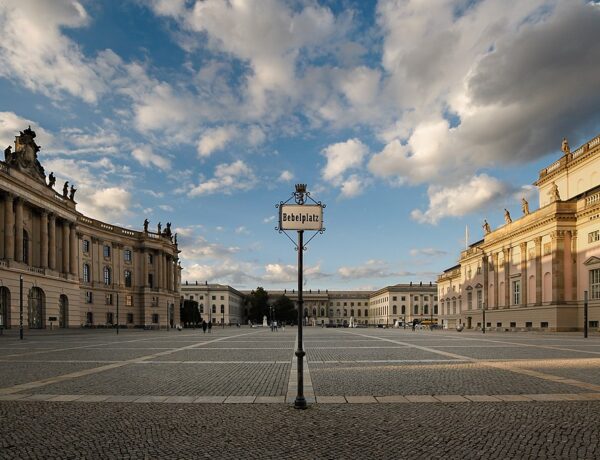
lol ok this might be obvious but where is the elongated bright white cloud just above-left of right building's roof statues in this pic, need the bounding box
[411,174,511,224]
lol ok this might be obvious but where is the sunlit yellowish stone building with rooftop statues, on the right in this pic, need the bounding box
[438,136,600,331]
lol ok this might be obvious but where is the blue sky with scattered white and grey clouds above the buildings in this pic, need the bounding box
[0,0,600,290]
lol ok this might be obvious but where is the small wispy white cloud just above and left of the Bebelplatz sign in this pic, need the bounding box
[188,160,257,197]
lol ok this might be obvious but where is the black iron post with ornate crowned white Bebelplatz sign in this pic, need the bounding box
[275,184,325,409]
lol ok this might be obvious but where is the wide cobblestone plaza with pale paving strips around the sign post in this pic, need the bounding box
[0,327,600,458]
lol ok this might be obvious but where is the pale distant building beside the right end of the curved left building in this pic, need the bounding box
[181,281,245,325]
